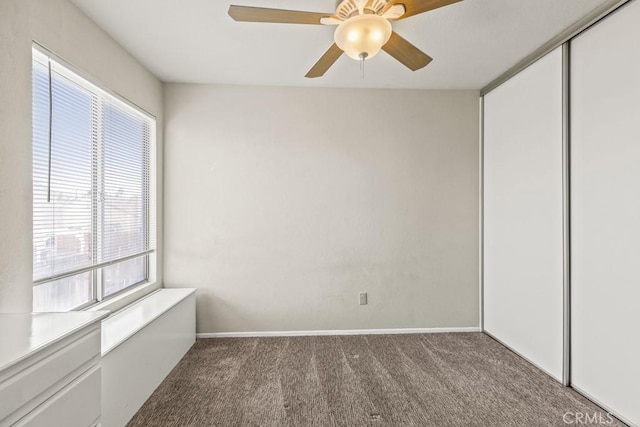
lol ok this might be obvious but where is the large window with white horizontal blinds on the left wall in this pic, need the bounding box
[33,48,155,311]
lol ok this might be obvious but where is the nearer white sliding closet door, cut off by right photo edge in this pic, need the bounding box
[571,0,640,425]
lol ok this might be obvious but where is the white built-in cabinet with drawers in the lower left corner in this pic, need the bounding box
[0,312,108,427]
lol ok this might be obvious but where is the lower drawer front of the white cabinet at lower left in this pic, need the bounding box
[15,366,102,427]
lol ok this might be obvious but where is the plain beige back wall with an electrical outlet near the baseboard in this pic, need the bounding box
[165,84,479,333]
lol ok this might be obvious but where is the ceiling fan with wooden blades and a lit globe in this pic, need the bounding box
[229,0,461,78]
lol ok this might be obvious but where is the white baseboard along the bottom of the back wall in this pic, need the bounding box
[196,326,480,338]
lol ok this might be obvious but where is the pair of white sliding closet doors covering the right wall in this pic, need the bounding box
[482,0,640,426]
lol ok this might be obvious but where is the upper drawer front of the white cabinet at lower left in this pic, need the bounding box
[0,329,100,420]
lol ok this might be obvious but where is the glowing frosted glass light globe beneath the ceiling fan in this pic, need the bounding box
[334,14,393,61]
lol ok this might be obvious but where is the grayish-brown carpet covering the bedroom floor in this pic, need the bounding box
[129,333,623,427]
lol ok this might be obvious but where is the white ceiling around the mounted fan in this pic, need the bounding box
[72,0,604,89]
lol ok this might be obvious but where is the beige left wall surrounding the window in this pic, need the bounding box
[0,0,163,312]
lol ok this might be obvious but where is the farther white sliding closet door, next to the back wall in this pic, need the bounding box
[484,48,563,380]
